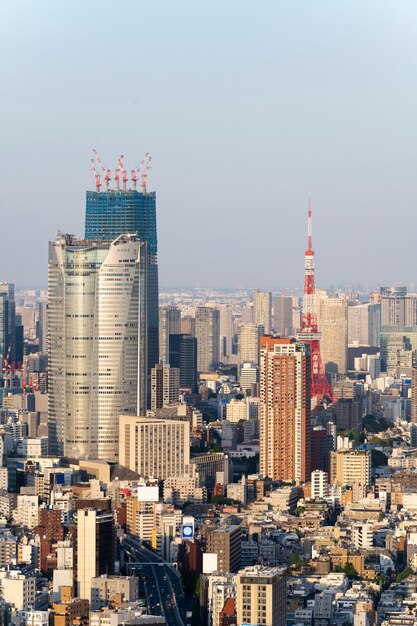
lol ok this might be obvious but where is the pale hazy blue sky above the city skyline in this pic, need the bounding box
[0,0,417,289]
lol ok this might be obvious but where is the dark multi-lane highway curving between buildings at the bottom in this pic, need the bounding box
[123,537,185,626]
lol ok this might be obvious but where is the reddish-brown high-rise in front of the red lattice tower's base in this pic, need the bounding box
[259,336,311,481]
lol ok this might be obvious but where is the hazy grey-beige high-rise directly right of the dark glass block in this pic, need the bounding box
[195,306,220,372]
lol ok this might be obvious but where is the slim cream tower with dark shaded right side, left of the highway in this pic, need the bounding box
[76,509,115,602]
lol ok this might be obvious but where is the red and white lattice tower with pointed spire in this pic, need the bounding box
[298,205,335,406]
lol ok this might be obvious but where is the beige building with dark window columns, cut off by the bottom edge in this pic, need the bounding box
[236,565,287,626]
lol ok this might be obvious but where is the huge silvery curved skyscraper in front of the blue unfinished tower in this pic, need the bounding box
[48,235,148,461]
